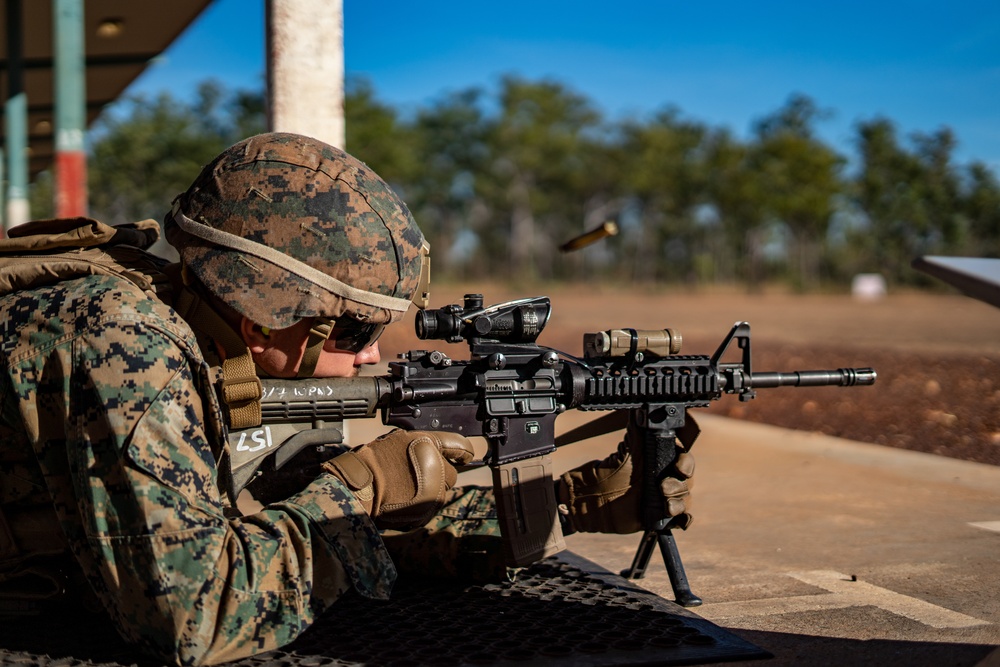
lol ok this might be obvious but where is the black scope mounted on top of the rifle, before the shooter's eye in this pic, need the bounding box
[414,294,552,343]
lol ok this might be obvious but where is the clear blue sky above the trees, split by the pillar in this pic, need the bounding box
[129,0,1000,173]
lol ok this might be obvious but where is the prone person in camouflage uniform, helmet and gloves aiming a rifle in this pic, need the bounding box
[0,133,693,664]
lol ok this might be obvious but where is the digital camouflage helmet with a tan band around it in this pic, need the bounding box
[165,133,429,329]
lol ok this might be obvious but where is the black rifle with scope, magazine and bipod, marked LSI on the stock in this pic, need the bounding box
[229,294,876,606]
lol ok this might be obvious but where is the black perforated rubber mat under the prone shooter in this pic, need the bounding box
[0,552,770,667]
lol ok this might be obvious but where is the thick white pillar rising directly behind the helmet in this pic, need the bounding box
[267,0,345,148]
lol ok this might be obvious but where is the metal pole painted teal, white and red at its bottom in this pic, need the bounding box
[52,0,87,218]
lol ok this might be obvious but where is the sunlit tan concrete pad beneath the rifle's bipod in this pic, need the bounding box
[351,412,1000,665]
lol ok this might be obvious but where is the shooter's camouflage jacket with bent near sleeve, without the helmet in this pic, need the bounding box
[0,276,395,663]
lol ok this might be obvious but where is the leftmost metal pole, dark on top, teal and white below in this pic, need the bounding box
[4,0,31,231]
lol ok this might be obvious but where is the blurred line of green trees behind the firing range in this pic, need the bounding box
[33,76,1000,290]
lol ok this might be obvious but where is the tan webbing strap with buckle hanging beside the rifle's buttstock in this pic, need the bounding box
[174,286,262,431]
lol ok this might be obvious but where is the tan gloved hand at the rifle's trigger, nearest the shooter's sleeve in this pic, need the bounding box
[323,430,475,530]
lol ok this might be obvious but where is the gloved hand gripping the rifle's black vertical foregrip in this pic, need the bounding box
[556,416,699,534]
